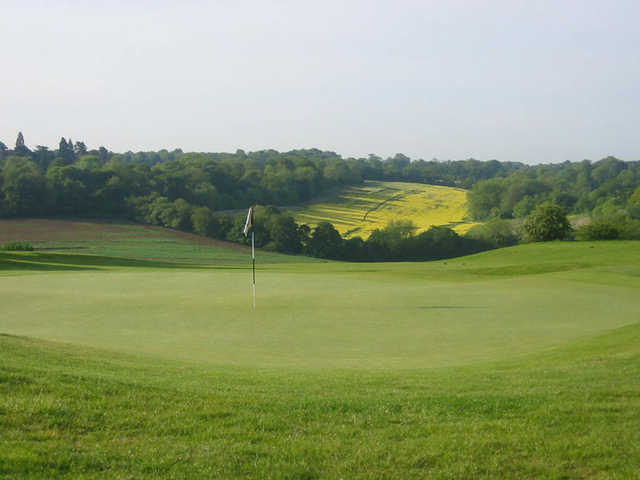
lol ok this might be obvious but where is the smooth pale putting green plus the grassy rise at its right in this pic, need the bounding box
[0,242,640,369]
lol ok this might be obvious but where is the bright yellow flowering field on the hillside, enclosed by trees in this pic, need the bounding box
[293,181,473,239]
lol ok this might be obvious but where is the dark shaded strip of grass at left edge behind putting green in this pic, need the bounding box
[0,252,207,271]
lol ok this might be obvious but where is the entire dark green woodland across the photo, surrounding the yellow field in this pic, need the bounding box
[0,133,640,260]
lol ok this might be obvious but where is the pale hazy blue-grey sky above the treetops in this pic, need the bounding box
[0,0,640,163]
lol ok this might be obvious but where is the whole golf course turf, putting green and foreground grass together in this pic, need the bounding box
[0,242,640,479]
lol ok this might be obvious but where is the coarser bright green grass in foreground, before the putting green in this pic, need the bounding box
[0,325,640,479]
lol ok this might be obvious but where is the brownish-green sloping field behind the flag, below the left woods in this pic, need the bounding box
[0,219,317,264]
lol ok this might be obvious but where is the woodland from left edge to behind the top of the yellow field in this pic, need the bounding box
[0,132,522,225]
